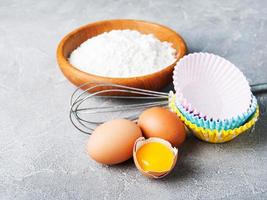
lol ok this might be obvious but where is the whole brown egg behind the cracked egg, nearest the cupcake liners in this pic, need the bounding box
[138,107,186,147]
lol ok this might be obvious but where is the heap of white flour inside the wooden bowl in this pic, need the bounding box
[69,30,176,77]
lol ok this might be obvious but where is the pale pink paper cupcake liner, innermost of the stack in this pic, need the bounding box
[173,53,252,121]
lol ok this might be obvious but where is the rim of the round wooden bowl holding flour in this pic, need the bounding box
[57,19,187,82]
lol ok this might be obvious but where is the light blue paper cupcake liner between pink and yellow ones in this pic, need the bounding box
[175,96,257,130]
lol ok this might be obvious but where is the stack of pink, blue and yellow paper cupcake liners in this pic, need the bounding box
[169,53,259,143]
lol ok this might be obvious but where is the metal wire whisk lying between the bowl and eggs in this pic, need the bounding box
[69,82,267,134]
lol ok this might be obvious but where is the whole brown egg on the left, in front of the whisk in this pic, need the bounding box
[87,119,142,165]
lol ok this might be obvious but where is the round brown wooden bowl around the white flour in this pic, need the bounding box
[57,19,187,95]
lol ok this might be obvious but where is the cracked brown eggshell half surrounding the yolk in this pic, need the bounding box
[133,137,178,179]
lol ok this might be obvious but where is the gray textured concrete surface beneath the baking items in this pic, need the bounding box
[0,0,267,200]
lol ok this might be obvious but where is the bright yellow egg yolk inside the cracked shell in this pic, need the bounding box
[136,142,174,172]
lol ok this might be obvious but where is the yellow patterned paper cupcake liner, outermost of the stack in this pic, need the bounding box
[169,95,259,143]
